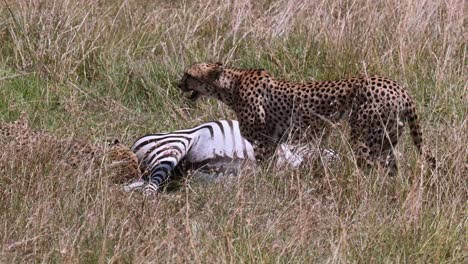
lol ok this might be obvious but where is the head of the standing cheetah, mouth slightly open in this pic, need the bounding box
[178,62,224,101]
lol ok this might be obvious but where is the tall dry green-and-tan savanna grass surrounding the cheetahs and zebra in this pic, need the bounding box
[0,0,468,263]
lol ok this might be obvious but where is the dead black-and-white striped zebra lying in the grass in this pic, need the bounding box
[125,120,337,195]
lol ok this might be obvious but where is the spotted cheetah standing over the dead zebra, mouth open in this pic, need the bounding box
[178,63,434,172]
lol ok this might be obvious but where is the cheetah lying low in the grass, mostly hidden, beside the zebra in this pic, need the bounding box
[0,113,141,183]
